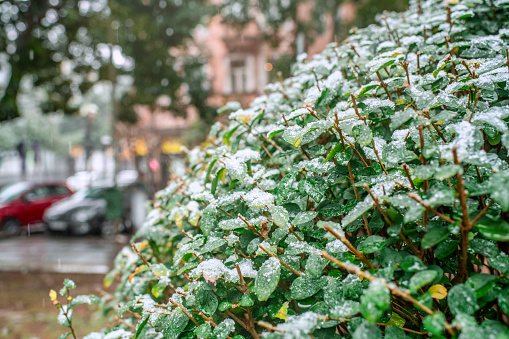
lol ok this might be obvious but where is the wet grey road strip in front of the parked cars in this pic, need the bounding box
[0,233,128,273]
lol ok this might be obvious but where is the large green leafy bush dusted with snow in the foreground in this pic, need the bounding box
[56,0,509,339]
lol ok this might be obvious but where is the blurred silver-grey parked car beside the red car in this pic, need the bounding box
[43,186,131,236]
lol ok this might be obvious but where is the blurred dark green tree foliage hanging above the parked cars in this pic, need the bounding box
[0,0,212,121]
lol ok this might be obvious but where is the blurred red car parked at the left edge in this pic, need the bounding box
[0,182,72,234]
